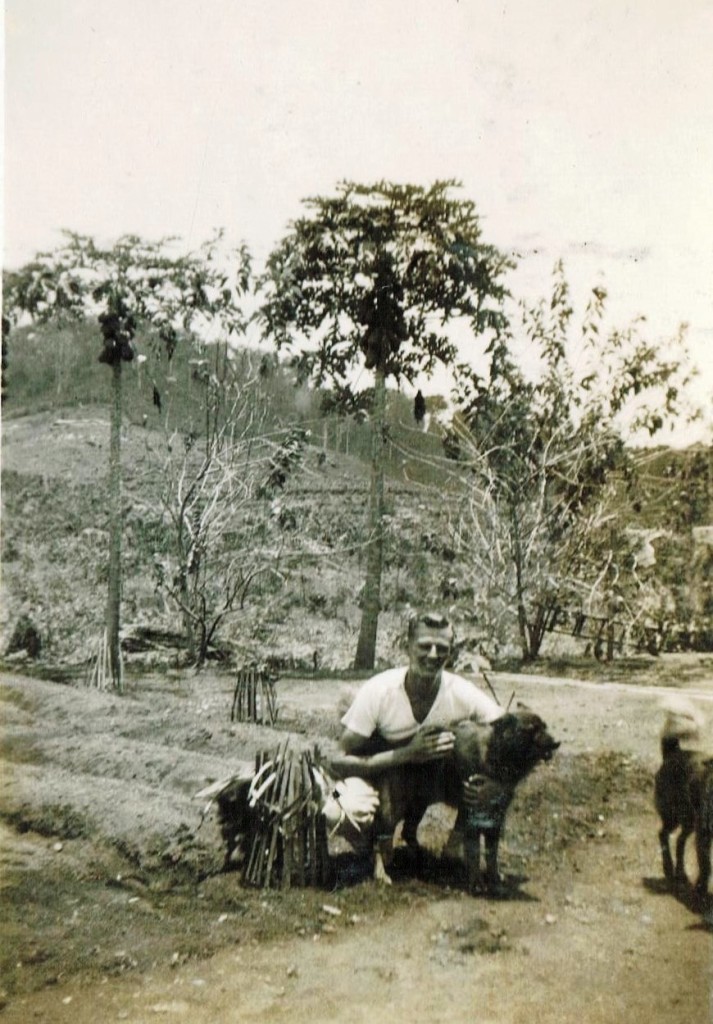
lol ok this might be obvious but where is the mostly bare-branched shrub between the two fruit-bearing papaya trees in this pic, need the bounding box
[151,359,304,668]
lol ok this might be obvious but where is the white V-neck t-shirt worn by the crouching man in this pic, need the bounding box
[341,668,503,743]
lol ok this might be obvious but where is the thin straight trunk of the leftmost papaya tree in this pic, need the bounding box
[107,359,124,692]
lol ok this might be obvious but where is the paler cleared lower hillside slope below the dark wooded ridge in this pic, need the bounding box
[0,407,456,669]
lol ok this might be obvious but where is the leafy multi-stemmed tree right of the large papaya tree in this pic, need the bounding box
[446,263,688,659]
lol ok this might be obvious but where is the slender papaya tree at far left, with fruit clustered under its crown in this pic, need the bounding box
[3,231,250,689]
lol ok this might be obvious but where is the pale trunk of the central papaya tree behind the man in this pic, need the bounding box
[354,368,386,669]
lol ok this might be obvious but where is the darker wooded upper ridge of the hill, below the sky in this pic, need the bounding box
[2,321,452,484]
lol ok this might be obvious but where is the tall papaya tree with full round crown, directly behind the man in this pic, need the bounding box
[259,181,510,669]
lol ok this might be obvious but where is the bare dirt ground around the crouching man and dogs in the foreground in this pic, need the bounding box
[0,656,713,1024]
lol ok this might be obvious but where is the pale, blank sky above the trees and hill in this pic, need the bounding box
[4,0,713,440]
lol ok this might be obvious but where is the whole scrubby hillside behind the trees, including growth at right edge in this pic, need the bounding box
[0,311,711,670]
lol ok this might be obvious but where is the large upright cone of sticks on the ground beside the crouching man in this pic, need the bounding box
[244,740,329,889]
